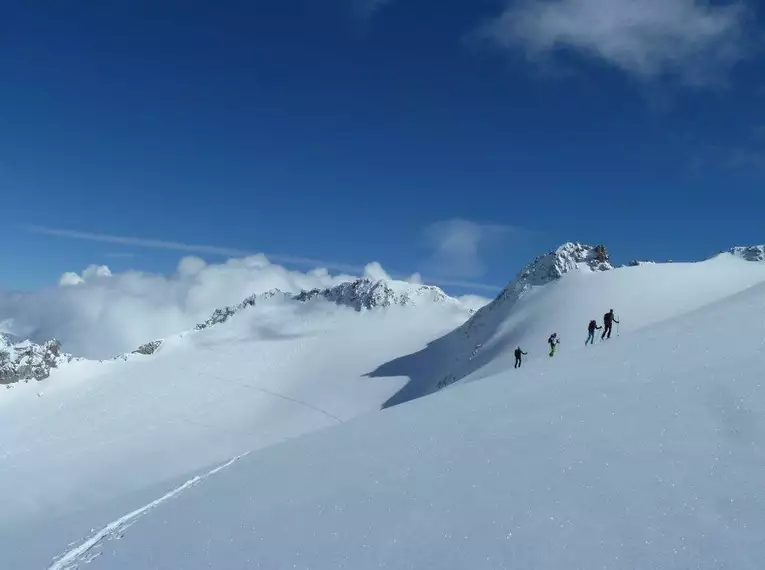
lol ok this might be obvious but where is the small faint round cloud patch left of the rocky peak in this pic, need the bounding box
[424,218,517,278]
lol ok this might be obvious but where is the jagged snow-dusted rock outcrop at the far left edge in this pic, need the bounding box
[0,334,81,387]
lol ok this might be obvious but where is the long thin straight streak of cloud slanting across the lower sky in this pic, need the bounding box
[22,225,501,292]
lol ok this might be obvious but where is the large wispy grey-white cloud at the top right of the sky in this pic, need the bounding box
[479,0,749,85]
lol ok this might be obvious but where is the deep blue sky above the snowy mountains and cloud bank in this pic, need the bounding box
[0,0,765,294]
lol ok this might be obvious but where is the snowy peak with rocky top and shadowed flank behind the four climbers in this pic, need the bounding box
[373,243,765,405]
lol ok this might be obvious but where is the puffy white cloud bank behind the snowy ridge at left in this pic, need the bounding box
[0,255,488,358]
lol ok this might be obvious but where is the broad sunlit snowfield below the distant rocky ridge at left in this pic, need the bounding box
[0,283,471,540]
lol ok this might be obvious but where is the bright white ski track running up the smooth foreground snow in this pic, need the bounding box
[47,452,249,570]
